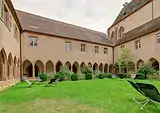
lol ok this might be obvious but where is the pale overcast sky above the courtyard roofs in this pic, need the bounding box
[12,0,131,32]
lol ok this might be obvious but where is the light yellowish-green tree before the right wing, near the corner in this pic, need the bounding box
[118,48,134,72]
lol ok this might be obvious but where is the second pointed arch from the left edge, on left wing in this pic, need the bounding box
[8,53,13,79]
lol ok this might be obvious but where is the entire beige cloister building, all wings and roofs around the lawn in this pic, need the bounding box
[0,0,160,86]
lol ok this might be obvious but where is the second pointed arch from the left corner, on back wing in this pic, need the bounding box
[34,60,44,77]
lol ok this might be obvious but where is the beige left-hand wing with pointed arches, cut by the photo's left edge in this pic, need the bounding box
[0,0,21,90]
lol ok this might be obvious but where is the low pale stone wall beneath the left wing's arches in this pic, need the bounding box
[0,79,20,91]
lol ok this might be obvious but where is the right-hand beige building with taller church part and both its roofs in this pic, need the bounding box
[108,0,160,71]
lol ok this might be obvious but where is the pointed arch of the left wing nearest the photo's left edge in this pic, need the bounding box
[0,49,7,81]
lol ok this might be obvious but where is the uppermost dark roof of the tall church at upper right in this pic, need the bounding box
[113,0,152,25]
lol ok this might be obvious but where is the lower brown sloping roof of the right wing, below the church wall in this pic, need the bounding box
[116,17,160,46]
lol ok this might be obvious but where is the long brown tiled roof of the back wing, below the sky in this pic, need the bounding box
[17,10,113,46]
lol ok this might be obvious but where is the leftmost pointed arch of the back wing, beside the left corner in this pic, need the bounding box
[23,60,33,77]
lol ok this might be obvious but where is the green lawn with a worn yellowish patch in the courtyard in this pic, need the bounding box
[0,79,160,113]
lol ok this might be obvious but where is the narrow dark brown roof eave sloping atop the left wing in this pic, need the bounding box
[5,0,22,30]
